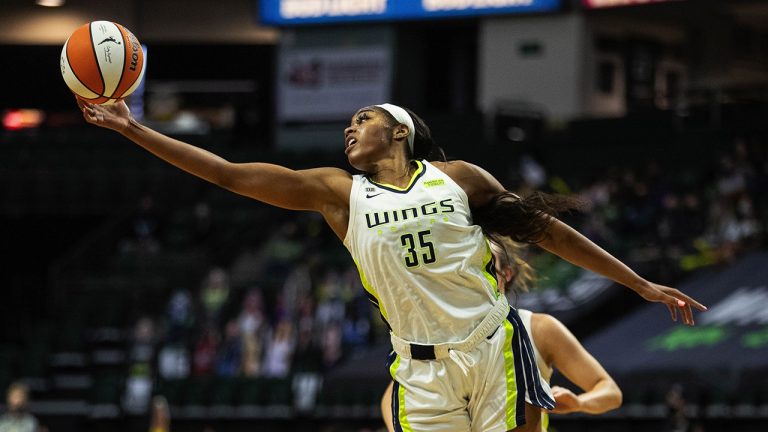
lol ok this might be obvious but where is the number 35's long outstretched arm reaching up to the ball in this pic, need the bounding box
[78,100,351,228]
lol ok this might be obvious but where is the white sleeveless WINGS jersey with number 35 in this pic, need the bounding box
[344,161,499,344]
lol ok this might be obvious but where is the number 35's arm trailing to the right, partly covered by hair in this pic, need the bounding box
[438,161,707,325]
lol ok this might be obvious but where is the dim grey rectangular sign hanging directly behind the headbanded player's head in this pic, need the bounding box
[277,46,392,122]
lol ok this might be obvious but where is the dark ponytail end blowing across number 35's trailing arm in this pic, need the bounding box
[472,191,583,244]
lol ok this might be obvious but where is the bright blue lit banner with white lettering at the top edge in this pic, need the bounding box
[259,0,561,26]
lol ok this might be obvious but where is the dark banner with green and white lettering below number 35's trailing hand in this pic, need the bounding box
[584,252,768,374]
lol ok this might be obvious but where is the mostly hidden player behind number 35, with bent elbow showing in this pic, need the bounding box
[381,241,622,432]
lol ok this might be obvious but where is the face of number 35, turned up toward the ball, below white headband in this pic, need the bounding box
[344,107,392,172]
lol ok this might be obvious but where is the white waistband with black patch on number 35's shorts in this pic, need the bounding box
[390,295,509,360]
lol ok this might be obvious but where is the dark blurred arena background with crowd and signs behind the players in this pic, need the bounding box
[0,0,768,432]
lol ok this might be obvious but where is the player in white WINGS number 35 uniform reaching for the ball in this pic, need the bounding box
[79,101,705,431]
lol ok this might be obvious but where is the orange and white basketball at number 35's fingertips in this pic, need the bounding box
[61,21,146,104]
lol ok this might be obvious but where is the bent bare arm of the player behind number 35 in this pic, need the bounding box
[532,314,622,414]
